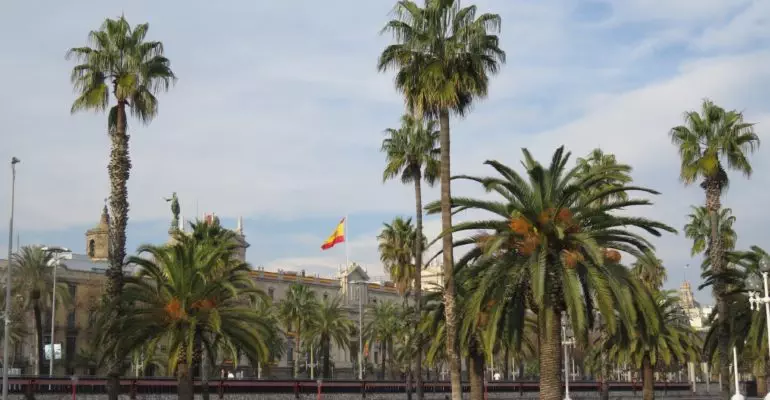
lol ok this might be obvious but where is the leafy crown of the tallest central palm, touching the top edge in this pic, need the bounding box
[377,0,505,116]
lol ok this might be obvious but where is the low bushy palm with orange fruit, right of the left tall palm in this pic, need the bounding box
[100,237,275,400]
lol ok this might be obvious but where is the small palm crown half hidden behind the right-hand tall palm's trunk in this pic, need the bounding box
[684,206,738,256]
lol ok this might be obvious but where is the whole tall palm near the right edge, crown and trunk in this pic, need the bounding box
[670,99,759,399]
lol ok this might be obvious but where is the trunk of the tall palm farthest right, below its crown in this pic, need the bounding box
[704,178,730,400]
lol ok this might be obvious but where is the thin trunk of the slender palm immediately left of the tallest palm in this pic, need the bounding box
[414,170,424,400]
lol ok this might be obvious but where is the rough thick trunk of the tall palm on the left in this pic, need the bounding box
[106,100,131,400]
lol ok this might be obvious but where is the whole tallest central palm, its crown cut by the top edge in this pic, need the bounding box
[377,0,505,400]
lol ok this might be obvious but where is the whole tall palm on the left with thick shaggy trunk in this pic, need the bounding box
[67,16,176,400]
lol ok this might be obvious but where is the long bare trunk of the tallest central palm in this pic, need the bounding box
[439,108,463,400]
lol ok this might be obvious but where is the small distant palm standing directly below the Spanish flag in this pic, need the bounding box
[305,296,354,379]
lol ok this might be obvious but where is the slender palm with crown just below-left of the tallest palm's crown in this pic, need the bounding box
[382,114,441,400]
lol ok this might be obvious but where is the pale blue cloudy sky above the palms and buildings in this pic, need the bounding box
[0,0,770,303]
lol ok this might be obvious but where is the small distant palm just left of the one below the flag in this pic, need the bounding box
[278,283,318,378]
